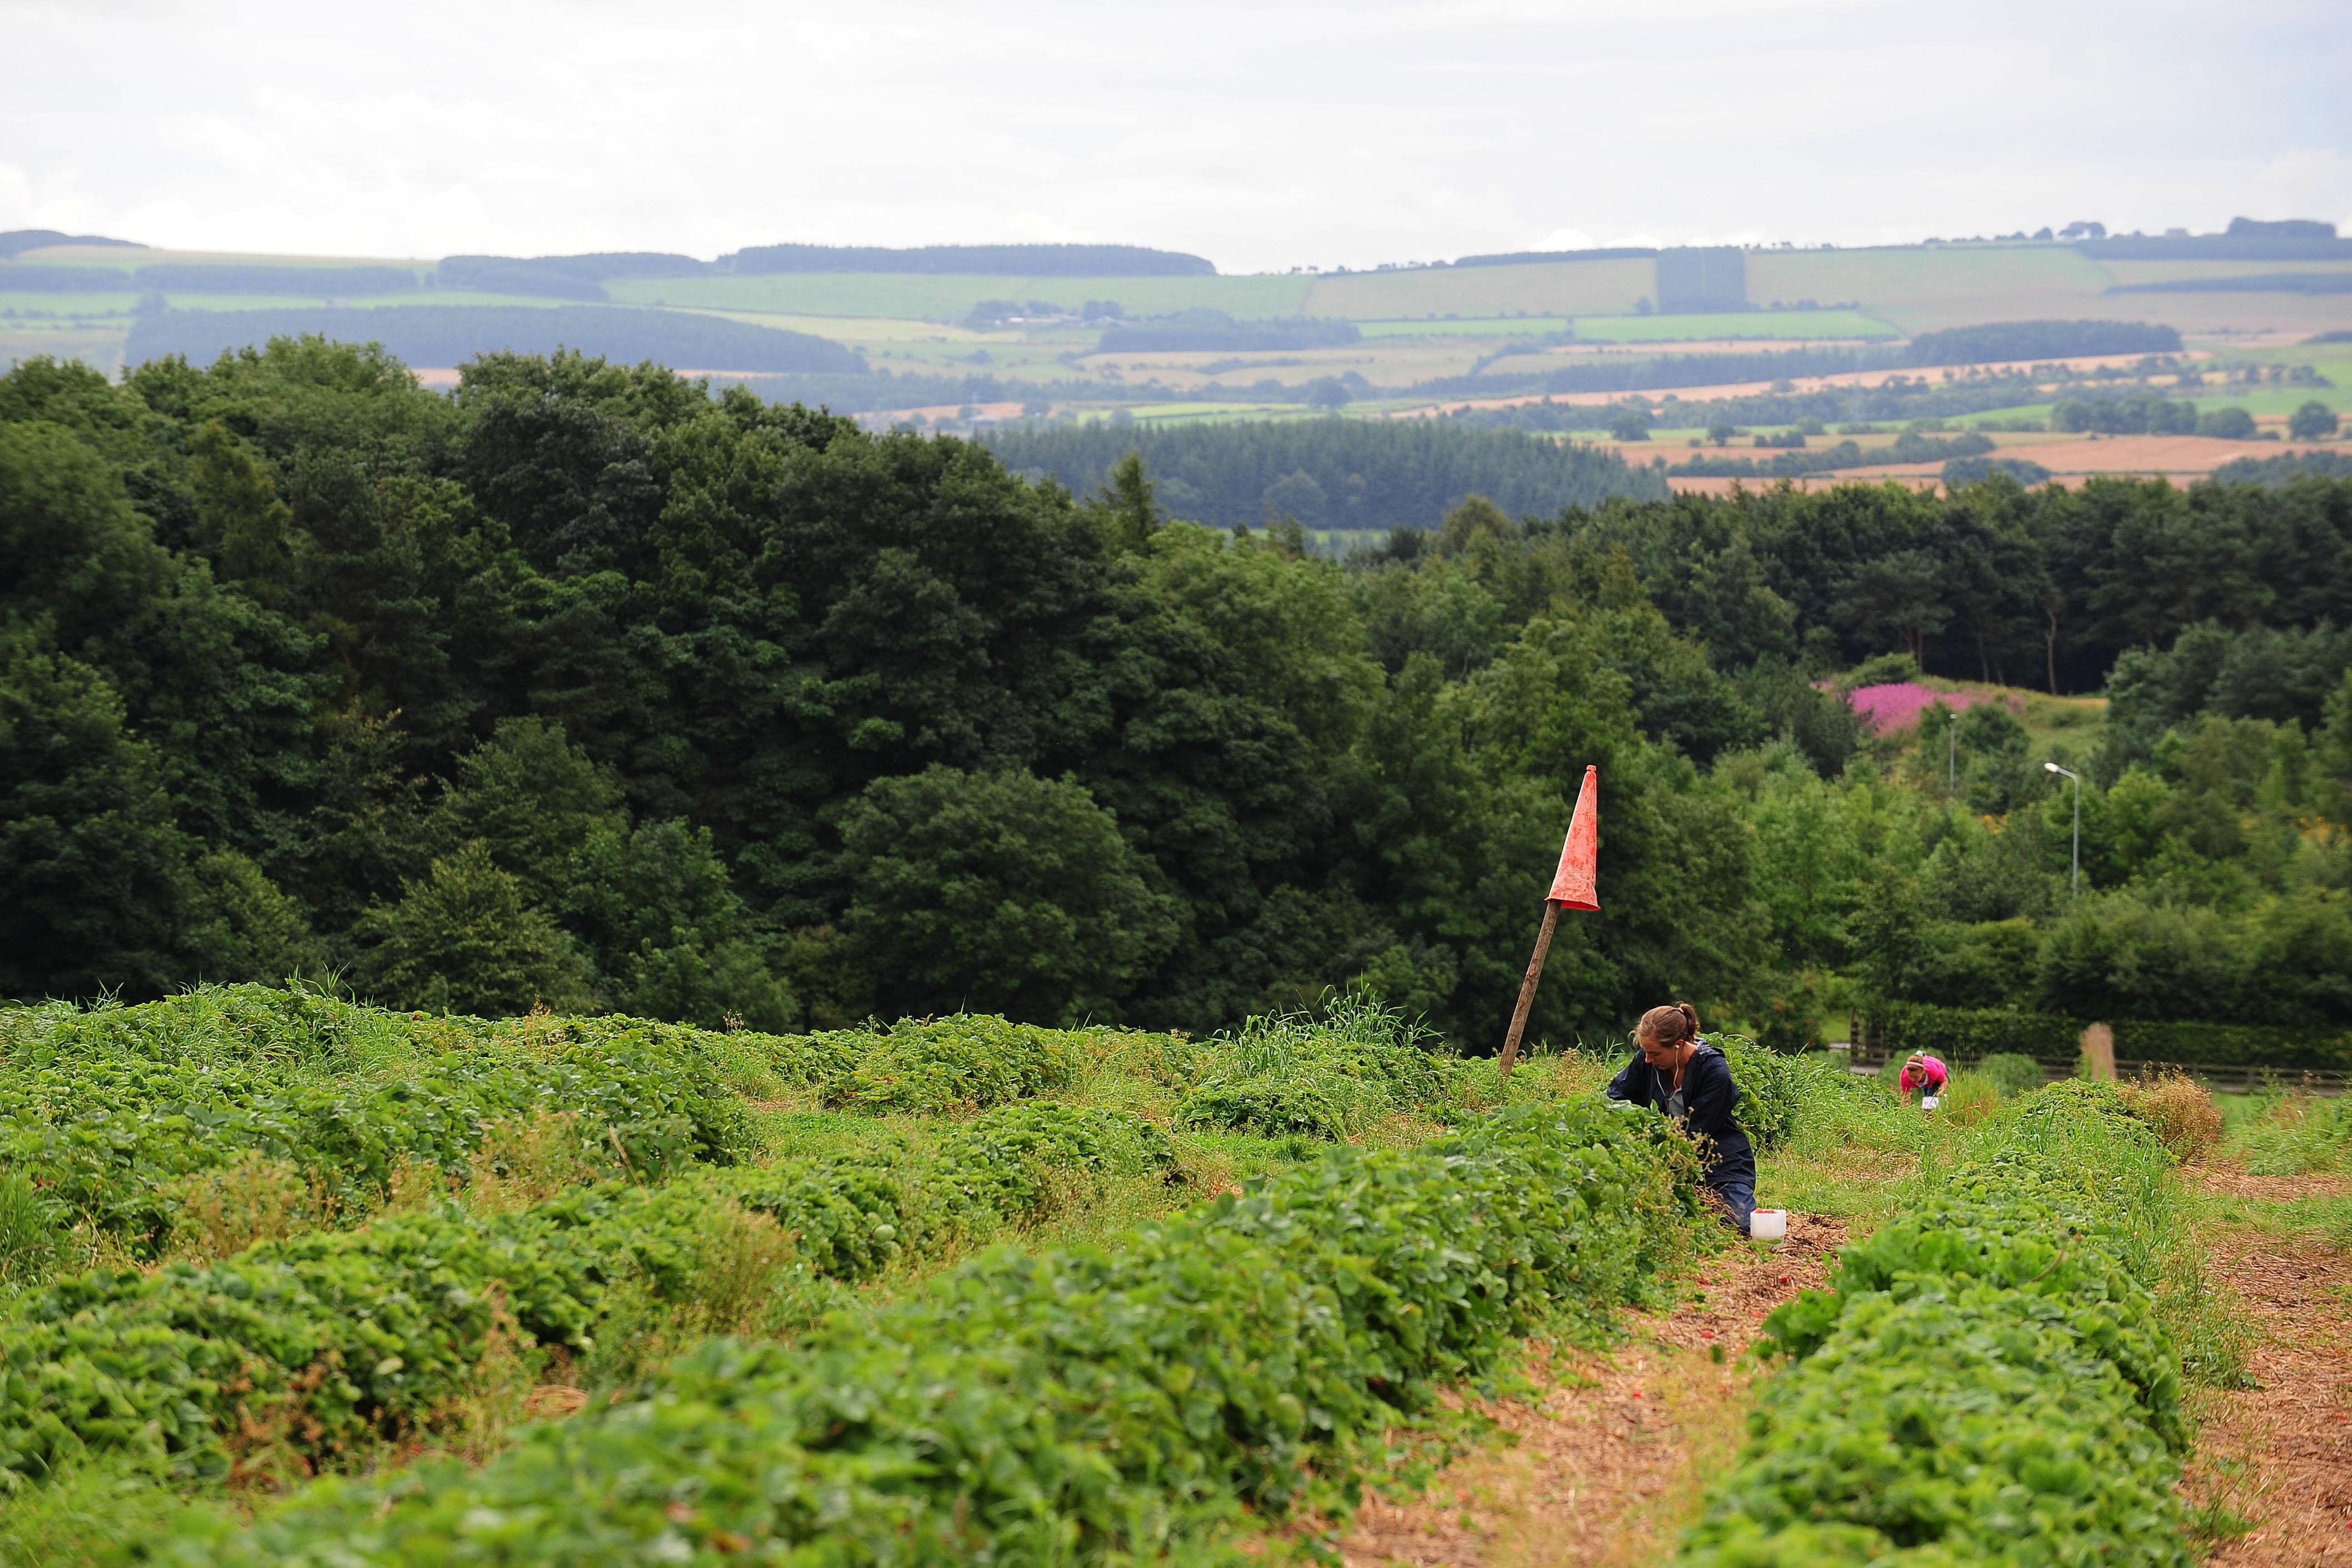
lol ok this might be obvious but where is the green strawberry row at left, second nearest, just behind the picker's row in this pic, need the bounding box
[0,1105,1173,1488]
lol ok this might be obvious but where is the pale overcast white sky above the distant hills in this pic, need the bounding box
[0,0,2352,272]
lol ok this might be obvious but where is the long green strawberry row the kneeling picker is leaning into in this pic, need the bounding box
[157,1103,1696,1568]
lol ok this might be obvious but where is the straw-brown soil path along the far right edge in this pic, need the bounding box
[2183,1222,2352,1568]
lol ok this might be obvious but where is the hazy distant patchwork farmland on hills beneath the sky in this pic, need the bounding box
[0,226,2352,489]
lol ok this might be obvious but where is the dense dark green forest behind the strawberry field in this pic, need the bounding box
[0,339,2352,1049]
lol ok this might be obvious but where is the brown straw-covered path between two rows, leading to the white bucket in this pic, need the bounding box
[1343,1213,1846,1568]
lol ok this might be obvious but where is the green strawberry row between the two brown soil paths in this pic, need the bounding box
[1682,1081,2187,1568]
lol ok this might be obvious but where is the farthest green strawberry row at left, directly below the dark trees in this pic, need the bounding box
[0,985,1138,1258]
